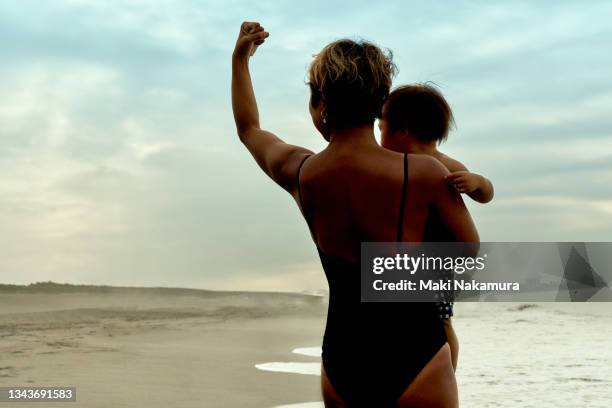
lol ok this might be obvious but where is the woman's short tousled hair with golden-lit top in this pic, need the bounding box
[309,39,397,128]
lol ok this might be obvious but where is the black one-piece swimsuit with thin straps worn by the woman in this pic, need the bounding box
[297,155,447,408]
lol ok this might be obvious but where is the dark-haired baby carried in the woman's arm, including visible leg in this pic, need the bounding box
[379,84,493,369]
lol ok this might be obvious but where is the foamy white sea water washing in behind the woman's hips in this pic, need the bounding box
[255,303,612,408]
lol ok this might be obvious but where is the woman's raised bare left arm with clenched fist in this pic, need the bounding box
[232,22,312,194]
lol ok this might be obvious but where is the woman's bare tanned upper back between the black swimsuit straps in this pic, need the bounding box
[296,135,446,261]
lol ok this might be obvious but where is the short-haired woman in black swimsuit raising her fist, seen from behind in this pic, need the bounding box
[232,23,478,407]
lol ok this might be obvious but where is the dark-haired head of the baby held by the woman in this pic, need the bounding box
[379,84,455,152]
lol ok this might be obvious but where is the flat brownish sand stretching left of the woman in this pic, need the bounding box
[0,286,326,408]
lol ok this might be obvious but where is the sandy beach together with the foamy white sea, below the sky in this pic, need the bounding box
[0,285,612,408]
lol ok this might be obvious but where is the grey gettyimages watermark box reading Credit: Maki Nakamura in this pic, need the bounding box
[361,242,612,302]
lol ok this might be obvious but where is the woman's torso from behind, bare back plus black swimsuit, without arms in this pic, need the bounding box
[297,131,460,407]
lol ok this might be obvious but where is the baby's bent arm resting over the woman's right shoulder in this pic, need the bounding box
[438,155,494,204]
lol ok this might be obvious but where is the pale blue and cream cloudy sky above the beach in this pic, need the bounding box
[0,0,612,291]
